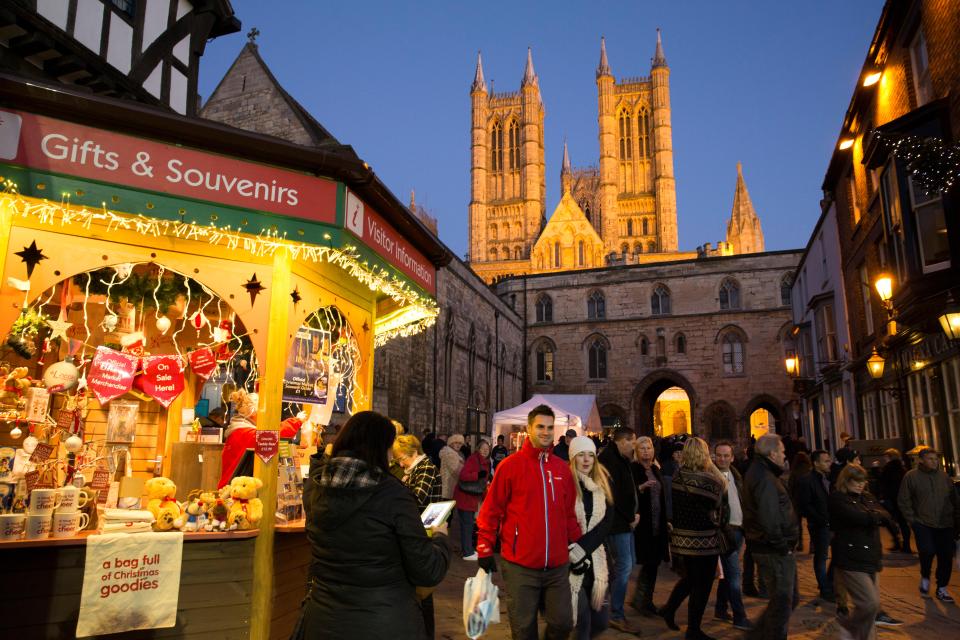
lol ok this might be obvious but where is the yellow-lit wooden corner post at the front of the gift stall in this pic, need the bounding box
[250,247,293,640]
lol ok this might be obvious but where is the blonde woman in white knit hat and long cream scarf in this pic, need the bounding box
[570,436,614,640]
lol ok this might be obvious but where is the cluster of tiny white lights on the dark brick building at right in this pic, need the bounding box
[877,132,960,196]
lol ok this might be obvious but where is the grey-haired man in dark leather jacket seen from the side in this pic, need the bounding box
[743,433,800,640]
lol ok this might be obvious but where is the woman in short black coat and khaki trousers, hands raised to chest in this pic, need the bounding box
[829,464,890,640]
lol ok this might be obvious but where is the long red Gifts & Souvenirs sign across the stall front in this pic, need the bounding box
[0,111,337,224]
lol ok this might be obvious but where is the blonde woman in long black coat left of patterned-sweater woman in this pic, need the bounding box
[630,436,670,616]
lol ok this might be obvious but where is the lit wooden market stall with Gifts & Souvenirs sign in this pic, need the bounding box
[0,75,448,639]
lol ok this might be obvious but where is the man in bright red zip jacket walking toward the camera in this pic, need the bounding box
[477,405,586,640]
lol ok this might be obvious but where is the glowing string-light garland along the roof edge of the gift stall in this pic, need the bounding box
[0,185,440,346]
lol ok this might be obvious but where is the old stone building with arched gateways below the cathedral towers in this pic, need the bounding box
[497,250,801,440]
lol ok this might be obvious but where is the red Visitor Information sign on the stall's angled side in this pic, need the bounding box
[343,190,437,295]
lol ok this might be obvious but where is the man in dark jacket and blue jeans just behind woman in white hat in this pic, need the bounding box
[597,427,640,633]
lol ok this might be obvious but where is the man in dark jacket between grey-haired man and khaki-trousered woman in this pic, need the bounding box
[797,449,836,602]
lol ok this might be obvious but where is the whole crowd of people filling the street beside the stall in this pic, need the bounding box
[297,405,960,640]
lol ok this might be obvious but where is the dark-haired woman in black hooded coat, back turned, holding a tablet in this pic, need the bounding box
[302,411,450,640]
